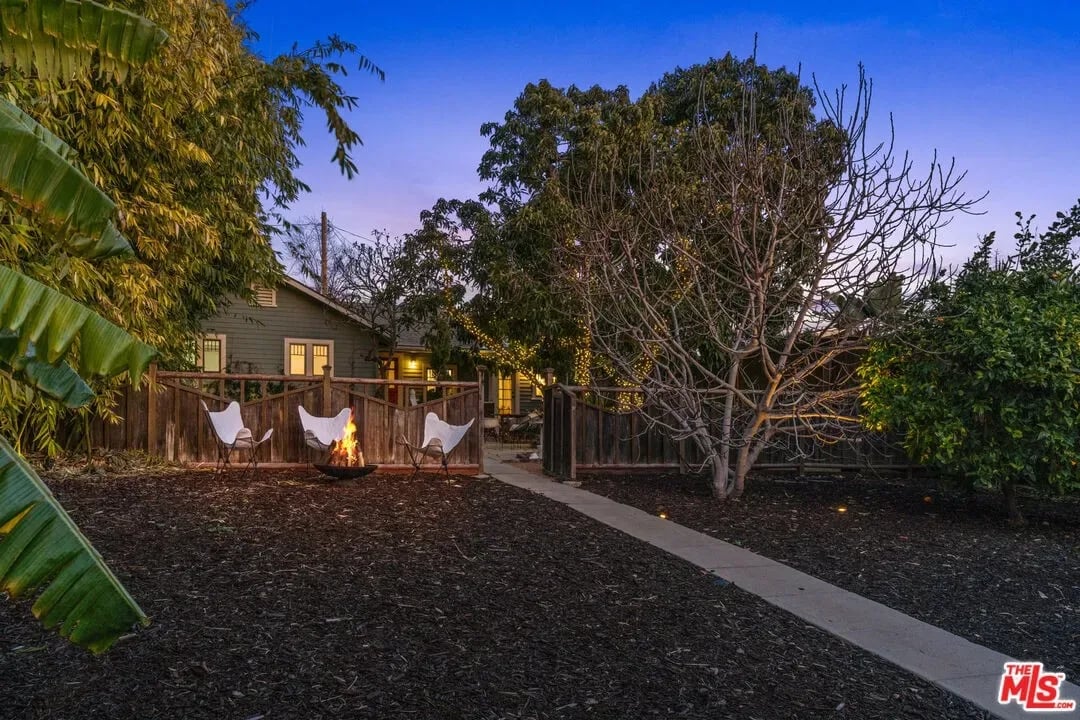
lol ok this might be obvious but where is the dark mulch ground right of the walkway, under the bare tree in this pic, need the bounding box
[582,475,1080,682]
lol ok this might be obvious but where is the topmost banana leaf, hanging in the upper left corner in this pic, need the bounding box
[0,0,168,80]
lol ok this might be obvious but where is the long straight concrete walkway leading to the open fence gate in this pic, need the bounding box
[484,453,1080,720]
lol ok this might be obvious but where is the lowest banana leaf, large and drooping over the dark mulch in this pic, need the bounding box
[0,437,150,652]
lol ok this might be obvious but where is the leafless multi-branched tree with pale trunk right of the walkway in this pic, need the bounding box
[559,68,975,498]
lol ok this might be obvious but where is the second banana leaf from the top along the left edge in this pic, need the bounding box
[0,97,132,258]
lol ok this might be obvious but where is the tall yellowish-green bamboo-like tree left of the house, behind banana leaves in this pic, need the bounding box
[0,0,382,452]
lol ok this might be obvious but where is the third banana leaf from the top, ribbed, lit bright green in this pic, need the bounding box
[0,266,158,384]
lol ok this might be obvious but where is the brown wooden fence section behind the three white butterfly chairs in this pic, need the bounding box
[91,369,484,472]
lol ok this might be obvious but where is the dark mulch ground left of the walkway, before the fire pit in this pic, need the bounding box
[0,472,984,720]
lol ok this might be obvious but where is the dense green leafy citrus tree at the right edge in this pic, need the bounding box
[860,204,1080,521]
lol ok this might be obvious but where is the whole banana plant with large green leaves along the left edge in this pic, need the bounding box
[0,0,166,652]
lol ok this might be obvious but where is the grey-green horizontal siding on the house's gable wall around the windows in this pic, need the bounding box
[203,285,376,378]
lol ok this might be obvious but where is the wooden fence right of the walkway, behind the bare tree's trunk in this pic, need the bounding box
[540,385,919,479]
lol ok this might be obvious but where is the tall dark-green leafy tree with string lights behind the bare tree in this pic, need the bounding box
[455,54,839,382]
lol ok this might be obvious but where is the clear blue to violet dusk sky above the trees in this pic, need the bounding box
[244,0,1080,266]
